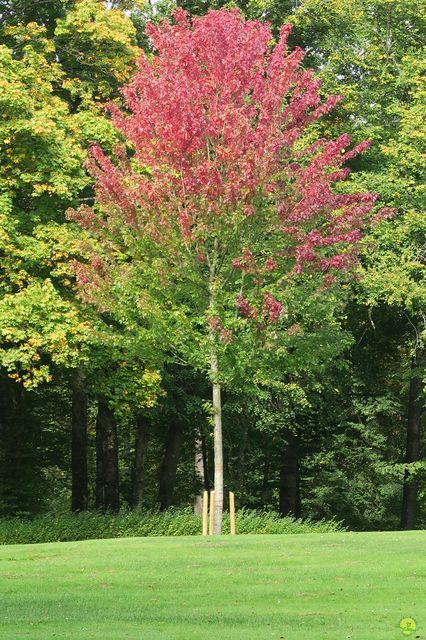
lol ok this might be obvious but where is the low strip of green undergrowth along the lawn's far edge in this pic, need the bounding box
[0,507,342,544]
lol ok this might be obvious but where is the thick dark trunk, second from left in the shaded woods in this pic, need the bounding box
[96,398,120,513]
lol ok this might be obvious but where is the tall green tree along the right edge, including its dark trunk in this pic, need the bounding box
[268,0,426,528]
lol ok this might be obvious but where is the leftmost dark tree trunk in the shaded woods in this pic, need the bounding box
[71,367,88,512]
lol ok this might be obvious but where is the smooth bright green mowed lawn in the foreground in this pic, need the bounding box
[0,531,426,640]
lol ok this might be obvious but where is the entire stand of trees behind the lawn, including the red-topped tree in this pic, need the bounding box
[0,0,426,532]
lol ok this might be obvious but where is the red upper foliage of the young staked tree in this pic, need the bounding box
[68,9,392,310]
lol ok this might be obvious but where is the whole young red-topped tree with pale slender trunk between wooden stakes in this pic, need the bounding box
[71,9,392,533]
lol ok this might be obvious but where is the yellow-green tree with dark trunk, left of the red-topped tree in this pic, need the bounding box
[0,15,161,511]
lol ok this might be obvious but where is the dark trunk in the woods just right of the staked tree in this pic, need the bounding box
[279,431,300,518]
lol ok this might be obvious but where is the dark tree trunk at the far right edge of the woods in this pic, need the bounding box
[401,351,426,529]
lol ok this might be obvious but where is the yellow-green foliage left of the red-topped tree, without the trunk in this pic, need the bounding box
[0,8,159,404]
